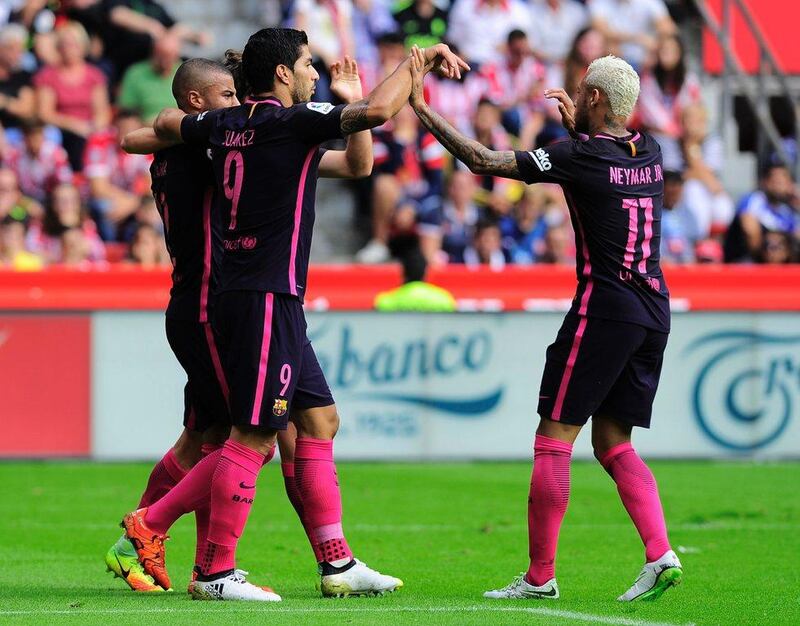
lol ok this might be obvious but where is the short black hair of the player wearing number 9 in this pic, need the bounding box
[242,28,308,94]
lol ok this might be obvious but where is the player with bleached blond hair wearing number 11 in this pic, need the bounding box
[411,50,683,601]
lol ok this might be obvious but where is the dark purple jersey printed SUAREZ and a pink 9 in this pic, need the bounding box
[181,98,344,300]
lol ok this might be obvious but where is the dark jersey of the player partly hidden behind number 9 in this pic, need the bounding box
[150,145,222,322]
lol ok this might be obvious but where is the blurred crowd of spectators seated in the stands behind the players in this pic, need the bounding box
[0,0,800,270]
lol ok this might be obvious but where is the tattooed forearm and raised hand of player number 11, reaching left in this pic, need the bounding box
[409,47,522,180]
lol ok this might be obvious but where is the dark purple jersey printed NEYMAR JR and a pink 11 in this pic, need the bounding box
[516,133,670,331]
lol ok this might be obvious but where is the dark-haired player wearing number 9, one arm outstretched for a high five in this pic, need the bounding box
[125,29,469,600]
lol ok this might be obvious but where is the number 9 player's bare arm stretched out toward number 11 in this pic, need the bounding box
[340,43,469,135]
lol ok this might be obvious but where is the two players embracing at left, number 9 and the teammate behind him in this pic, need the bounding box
[106,28,469,601]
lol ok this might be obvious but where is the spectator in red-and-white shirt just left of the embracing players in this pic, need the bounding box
[85,109,150,241]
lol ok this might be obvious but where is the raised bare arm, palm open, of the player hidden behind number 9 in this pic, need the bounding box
[319,56,373,178]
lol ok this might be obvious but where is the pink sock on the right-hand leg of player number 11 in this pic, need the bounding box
[600,442,670,563]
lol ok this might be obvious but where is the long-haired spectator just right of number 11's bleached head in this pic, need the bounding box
[634,35,701,170]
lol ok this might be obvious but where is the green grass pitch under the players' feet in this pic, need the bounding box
[0,462,800,626]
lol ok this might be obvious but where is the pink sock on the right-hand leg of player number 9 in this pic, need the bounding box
[294,437,353,567]
